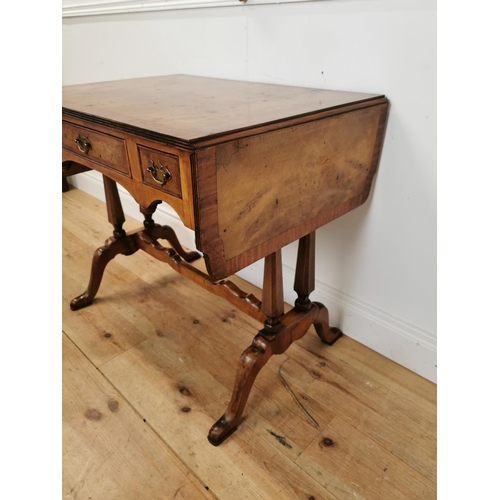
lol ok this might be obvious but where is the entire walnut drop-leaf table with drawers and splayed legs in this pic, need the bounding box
[62,75,388,445]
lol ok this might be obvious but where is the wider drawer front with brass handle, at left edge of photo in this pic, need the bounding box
[62,121,130,177]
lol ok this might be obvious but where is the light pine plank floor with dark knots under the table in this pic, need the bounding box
[62,188,436,500]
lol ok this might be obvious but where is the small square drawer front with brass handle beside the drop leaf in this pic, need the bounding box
[137,145,182,199]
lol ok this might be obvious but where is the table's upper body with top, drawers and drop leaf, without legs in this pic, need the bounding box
[63,75,388,280]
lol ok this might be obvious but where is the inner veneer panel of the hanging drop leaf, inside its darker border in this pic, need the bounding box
[215,106,383,260]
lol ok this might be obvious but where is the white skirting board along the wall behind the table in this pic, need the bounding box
[68,172,437,383]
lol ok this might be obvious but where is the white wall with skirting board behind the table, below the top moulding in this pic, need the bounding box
[63,0,436,381]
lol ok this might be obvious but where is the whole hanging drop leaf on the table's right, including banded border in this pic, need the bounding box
[193,101,388,279]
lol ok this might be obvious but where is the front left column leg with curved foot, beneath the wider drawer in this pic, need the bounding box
[70,175,138,311]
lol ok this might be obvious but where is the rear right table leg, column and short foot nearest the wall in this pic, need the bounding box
[293,231,342,345]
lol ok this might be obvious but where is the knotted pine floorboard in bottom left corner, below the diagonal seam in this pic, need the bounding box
[62,334,213,500]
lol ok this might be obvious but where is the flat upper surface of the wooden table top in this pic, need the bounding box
[62,75,383,144]
